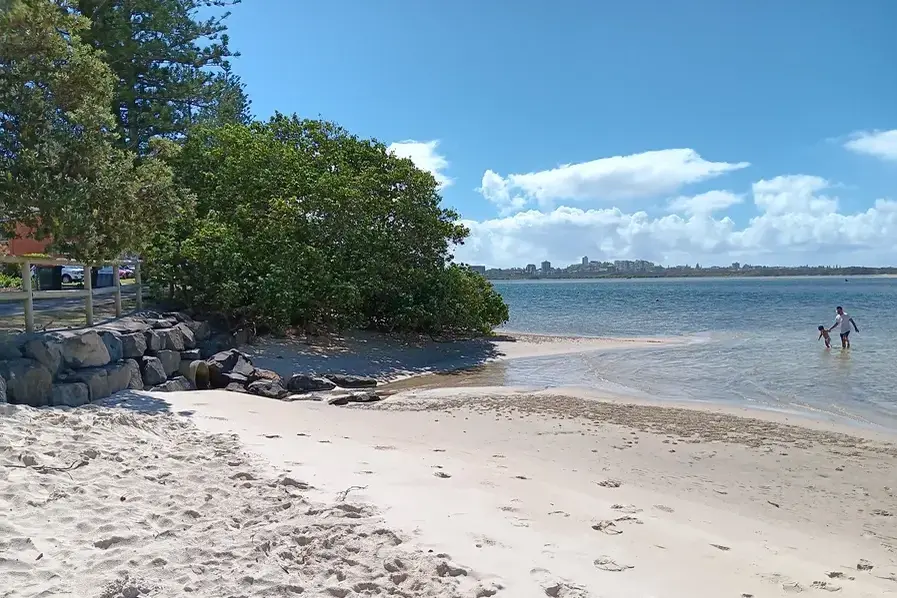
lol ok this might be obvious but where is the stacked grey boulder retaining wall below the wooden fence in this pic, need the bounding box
[0,312,251,407]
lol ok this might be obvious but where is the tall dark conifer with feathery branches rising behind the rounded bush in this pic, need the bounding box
[75,0,249,155]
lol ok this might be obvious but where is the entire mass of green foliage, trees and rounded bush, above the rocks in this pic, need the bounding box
[0,0,508,335]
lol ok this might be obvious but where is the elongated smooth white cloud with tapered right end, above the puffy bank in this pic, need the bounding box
[479,149,749,213]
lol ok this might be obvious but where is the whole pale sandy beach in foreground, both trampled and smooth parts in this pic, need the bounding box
[0,336,897,598]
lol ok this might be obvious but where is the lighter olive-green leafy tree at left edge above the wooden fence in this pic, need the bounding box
[0,0,179,261]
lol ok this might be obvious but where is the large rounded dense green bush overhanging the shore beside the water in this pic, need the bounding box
[144,114,508,334]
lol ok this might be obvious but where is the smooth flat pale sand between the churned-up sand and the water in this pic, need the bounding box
[149,393,897,598]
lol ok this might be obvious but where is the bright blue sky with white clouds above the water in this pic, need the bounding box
[220,0,897,266]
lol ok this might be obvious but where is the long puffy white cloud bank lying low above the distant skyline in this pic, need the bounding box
[456,175,897,267]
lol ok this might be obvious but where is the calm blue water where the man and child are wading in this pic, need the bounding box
[495,277,897,430]
